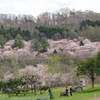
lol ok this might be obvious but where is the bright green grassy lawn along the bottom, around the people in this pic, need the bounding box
[0,86,100,100]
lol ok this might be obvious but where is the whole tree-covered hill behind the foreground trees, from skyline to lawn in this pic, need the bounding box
[0,8,100,89]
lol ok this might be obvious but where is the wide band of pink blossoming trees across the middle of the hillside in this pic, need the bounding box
[0,37,100,57]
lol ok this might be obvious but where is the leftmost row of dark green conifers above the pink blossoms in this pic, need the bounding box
[0,25,31,41]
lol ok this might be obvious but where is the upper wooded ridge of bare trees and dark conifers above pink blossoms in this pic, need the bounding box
[0,8,100,41]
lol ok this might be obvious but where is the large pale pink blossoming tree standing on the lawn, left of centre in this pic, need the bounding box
[19,65,44,95]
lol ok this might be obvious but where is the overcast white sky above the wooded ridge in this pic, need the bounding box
[0,0,100,17]
